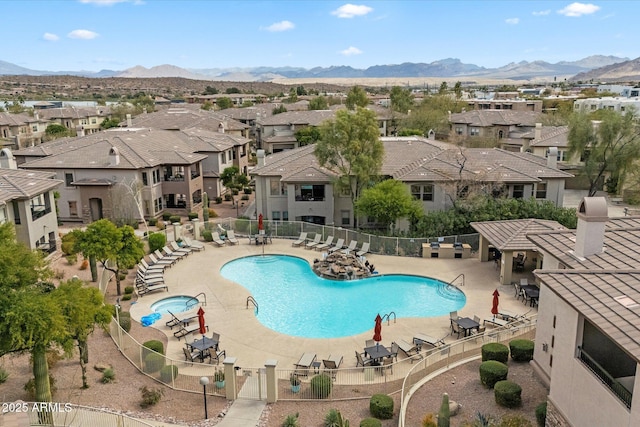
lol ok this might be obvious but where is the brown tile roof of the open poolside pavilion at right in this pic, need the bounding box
[470,218,566,251]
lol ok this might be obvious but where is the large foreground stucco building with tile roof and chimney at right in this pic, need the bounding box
[527,197,640,426]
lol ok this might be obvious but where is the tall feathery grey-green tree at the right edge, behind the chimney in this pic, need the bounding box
[567,110,640,196]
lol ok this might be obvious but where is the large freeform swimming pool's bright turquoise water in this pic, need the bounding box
[220,255,466,338]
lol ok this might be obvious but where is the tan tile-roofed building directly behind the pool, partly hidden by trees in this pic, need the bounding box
[251,137,572,227]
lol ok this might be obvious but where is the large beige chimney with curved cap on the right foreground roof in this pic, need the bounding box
[574,197,609,258]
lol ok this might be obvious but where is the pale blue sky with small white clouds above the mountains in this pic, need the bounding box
[0,0,640,71]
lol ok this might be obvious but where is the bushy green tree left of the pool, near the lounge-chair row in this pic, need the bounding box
[72,219,144,295]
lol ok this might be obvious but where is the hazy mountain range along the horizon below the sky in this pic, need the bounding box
[0,55,640,82]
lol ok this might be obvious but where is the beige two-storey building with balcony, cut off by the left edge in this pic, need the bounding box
[0,148,62,253]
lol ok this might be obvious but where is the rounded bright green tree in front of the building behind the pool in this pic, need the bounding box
[355,179,422,234]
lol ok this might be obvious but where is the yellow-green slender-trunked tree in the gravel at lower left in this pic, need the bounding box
[53,278,111,388]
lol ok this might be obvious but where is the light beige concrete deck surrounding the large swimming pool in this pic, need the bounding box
[130,238,537,369]
